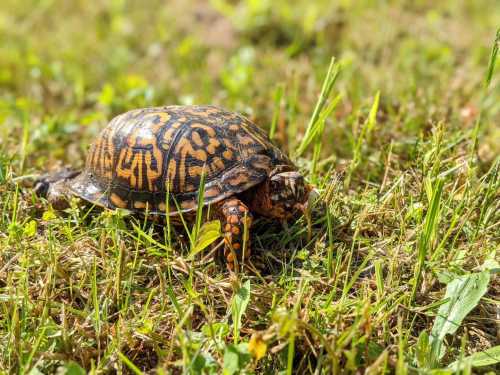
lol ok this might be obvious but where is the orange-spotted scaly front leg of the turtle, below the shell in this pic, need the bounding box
[221,198,252,270]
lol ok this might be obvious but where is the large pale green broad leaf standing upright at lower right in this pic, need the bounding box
[430,271,490,362]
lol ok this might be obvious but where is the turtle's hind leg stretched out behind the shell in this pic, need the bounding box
[34,168,80,210]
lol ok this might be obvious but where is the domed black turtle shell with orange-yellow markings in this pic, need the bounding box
[69,106,294,215]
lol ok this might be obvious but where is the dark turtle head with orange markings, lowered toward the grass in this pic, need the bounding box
[267,171,311,219]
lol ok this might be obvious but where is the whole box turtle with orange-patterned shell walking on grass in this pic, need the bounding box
[35,105,313,269]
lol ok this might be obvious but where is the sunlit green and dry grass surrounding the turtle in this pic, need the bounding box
[0,0,500,374]
